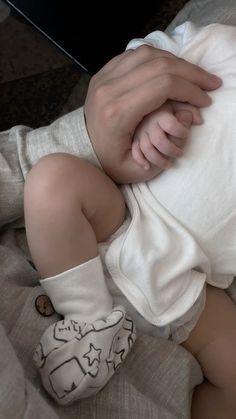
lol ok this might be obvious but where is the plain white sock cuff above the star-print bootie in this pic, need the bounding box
[40,256,112,322]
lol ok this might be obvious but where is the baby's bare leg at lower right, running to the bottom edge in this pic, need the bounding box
[183,286,236,419]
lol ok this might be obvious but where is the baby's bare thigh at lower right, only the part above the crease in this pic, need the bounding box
[182,285,236,388]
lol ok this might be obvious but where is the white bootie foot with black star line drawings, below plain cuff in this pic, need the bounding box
[34,306,136,405]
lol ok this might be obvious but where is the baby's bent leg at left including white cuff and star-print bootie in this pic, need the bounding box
[24,153,135,404]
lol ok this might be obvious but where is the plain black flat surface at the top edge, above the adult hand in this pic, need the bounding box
[7,0,165,74]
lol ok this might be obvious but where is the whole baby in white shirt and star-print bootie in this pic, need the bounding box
[25,22,236,419]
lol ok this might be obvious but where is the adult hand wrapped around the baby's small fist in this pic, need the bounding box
[84,45,221,183]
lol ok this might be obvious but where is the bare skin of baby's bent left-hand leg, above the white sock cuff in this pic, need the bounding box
[24,153,125,278]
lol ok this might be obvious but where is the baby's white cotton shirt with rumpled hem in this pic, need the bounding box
[106,22,236,326]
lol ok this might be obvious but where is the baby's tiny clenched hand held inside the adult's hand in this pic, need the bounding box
[132,101,203,170]
